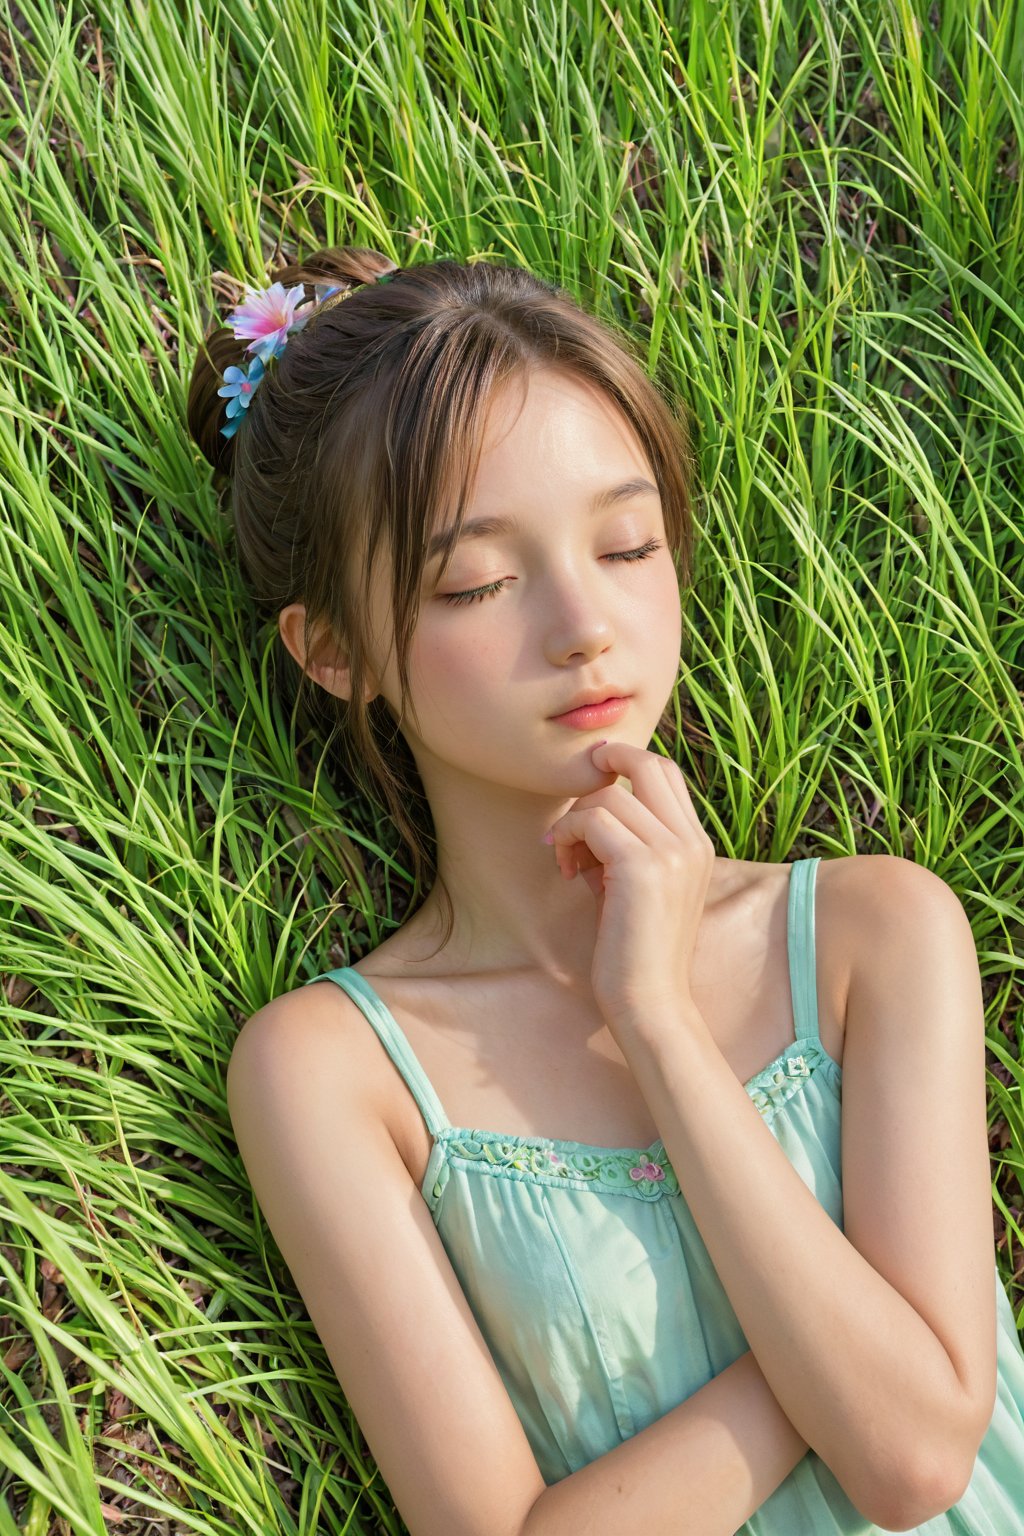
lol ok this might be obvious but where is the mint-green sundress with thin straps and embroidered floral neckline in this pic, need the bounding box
[307,859,1024,1536]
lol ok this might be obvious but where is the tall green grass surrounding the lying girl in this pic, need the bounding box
[0,0,1024,1536]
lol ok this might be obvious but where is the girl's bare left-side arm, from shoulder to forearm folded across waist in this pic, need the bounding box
[227,986,808,1536]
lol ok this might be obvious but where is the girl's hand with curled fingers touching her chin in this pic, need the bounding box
[545,742,715,1044]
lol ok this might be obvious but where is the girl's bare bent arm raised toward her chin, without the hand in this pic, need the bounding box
[619,856,995,1528]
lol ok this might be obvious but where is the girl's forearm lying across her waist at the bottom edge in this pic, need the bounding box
[520,1350,808,1536]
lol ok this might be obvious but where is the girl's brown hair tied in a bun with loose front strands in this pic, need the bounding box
[189,246,694,952]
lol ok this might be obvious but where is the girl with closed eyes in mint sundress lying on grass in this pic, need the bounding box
[189,249,1024,1536]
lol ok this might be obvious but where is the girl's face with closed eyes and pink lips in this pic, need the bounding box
[360,369,682,799]
